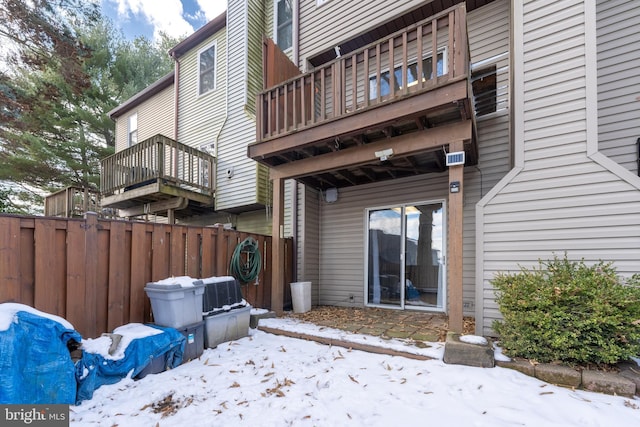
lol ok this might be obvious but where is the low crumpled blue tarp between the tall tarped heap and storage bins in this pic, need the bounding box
[76,325,186,404]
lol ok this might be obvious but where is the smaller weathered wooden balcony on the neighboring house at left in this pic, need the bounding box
[100,135,215,217]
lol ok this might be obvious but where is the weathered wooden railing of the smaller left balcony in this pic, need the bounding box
[100,135,215,196]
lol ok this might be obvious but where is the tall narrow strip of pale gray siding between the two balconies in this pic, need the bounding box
[216,0,264,210]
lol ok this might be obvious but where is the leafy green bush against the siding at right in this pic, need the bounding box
[492,254,640,364]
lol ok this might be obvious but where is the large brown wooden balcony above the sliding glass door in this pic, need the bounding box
[248,3,477,188]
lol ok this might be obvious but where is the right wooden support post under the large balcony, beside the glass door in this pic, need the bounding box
[447,140,464,333]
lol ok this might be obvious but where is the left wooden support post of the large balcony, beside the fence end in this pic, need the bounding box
[271,178,285,316]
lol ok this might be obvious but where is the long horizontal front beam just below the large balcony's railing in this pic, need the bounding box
[247,76,468,161]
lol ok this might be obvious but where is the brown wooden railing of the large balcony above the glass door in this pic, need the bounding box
[257,3,469,142]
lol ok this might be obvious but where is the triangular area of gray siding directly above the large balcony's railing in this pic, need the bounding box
[299,0,425,68]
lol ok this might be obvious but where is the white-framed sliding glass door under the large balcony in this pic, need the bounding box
[366,201,446,311]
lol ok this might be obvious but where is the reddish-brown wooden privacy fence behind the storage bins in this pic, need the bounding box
[0,213,293,338]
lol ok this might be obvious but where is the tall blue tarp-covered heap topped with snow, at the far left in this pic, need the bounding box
[0,303,82,404]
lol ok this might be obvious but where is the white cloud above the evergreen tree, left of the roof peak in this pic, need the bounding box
[113,0,194,38]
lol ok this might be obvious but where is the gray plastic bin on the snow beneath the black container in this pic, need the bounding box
[204,305,251,348]
